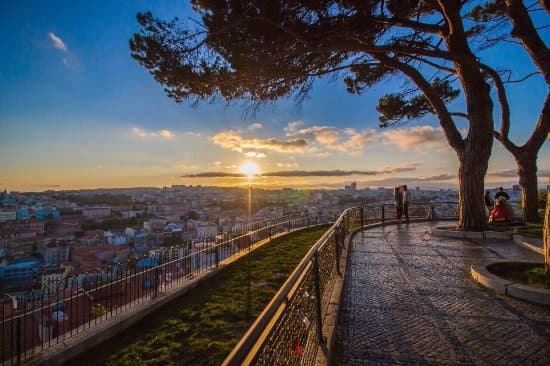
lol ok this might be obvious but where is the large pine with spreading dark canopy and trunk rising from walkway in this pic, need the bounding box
[130,0,550,227]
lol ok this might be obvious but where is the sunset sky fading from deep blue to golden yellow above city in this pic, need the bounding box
[0,0,550,191]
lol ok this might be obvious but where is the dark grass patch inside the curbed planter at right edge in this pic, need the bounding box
[487,262,550,289]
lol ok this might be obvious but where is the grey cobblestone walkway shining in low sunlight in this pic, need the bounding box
[336,223,550,365]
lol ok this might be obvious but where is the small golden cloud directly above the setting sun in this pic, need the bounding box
[211,130,309,153]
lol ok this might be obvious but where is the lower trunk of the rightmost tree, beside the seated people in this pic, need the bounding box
[515,153,539,222]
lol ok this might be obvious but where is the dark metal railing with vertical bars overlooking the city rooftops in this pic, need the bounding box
[0,214,334,365]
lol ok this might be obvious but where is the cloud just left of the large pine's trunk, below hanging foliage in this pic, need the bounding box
[383,125,447,150]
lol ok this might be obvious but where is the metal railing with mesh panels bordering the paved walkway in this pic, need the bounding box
[223,202,458,366]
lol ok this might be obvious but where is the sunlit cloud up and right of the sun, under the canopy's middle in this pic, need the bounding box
[283,121,376,155]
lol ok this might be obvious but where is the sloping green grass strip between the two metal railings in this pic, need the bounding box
[75,225,329,366]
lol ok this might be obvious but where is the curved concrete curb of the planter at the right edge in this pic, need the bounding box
[470,261,550,306]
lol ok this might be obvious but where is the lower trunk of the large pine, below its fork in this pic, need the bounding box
[458,151,490,230]
